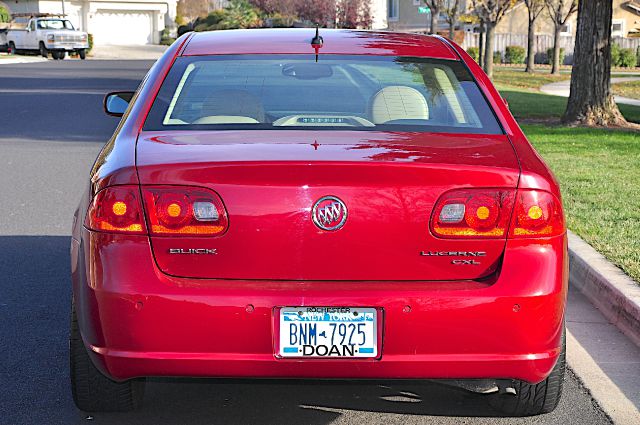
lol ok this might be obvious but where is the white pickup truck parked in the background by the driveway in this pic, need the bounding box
[7,17,89,59]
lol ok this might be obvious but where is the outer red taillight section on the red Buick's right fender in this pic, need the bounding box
[509,190,565,238]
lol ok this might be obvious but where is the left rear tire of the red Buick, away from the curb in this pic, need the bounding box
[69,303,145,412]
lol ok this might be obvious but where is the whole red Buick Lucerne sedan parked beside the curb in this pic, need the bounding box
[70,29,567,415]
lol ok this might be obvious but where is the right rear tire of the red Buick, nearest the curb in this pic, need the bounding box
[491,333,567,416]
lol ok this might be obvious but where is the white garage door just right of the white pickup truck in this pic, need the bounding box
[89,10,153,45]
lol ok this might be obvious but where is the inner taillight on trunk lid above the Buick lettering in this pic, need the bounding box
[142,186,229,236]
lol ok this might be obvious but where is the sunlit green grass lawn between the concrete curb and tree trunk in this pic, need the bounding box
[522,124,640,282]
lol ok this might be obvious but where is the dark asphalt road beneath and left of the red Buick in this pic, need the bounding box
[0,61,610,425]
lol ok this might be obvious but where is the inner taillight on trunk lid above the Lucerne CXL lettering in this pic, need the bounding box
[431,189,515,238]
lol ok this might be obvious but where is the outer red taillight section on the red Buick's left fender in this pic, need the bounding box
[85,186,146,234]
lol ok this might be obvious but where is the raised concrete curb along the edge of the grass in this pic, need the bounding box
[568,232,640,346]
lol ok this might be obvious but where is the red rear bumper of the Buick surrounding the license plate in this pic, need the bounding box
[72,230,567,382]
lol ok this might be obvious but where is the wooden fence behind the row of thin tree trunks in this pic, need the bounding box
[462,31,640,64]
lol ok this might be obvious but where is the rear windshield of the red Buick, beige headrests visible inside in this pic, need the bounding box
[144,55,502,134]
